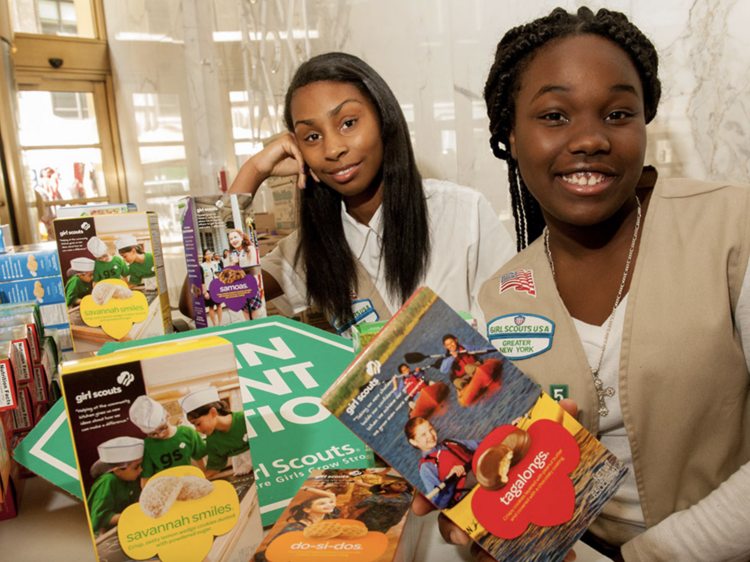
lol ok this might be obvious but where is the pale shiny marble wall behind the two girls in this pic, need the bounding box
[104,0,750,302]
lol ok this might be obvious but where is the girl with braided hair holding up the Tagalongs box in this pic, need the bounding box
[417,8,750,562]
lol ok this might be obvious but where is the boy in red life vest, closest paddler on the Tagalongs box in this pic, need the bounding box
[404,416,479,509]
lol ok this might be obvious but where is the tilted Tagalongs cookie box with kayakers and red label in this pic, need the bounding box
[323,288,627,562]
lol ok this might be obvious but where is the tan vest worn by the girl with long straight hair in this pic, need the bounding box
[278,230,391,334]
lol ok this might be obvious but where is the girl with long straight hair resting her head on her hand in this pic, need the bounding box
[231,53,514,334]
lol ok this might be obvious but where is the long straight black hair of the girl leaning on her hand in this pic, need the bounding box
[284,53,430,321]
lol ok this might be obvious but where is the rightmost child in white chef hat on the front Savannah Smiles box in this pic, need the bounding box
[180,386,253,478]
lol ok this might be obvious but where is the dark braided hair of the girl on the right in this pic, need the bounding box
[484,7,661,252]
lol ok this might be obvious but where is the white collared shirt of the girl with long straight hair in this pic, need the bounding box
[261,179,515,326]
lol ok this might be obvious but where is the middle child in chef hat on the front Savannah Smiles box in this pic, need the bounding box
[130,396,206,486]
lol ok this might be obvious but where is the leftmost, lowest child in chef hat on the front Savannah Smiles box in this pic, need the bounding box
[87,437,143,535]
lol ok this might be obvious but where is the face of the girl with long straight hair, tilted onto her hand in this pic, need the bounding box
[291,82,383,201]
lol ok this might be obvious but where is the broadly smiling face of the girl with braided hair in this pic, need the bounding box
[510,35,646,226]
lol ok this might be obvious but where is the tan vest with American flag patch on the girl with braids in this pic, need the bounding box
[479,180,750,527]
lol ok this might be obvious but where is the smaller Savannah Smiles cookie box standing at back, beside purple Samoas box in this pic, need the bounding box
[54,213,172,352]
